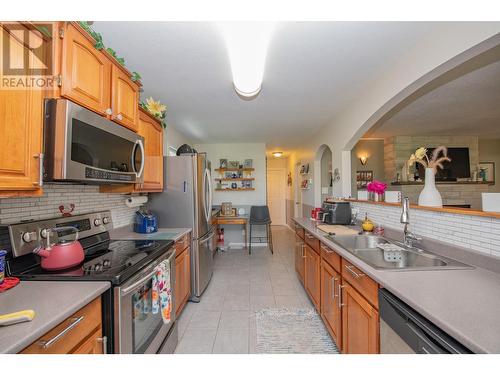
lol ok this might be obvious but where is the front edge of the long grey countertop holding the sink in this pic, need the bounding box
[293,218,495,354]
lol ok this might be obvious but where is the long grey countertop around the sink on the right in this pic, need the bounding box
[294,218,500,353]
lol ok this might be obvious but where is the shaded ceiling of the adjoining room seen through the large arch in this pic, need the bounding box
[366,61,500,138]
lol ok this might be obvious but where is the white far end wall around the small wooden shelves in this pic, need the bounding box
[194,143,266,206]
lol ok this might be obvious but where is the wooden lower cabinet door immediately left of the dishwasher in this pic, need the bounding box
[342,282,379,354]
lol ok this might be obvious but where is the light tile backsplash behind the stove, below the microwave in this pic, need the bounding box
[0,184,145,228]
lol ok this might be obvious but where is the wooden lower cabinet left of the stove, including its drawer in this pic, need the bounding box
[21,297,106,354]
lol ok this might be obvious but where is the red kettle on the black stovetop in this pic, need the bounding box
[33,226,85,271]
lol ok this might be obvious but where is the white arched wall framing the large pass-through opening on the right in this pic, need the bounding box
[294,22,499,210]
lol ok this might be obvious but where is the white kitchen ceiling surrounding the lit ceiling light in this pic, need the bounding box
[94,22,452,150]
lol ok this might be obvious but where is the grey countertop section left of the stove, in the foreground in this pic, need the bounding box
[0,281,111,353]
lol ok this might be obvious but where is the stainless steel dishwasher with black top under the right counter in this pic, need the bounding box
[378,289,472,354]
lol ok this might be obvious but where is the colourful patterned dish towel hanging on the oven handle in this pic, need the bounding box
[152,259,173,324]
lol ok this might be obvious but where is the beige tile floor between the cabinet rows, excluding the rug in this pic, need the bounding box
[176,226,312,353]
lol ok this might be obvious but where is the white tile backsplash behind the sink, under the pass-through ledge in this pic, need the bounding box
[352,202,500,257]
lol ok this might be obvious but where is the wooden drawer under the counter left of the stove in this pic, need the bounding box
[21,297,101,354]
